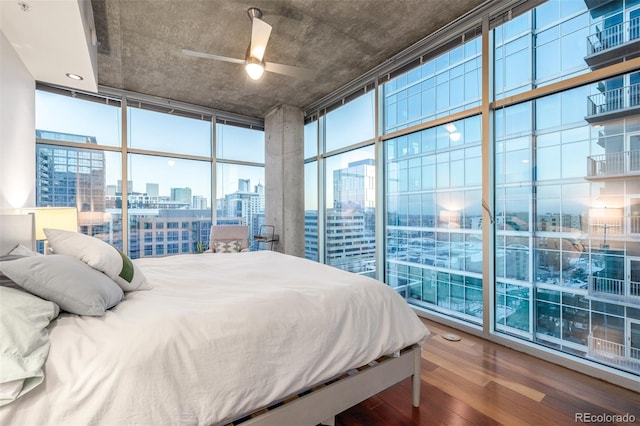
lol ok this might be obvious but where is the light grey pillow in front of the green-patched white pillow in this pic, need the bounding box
[0,254,123,316]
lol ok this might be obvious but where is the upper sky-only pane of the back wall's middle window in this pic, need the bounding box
[127,106,211,157]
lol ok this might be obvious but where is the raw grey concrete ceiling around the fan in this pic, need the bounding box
[91,0,484,117]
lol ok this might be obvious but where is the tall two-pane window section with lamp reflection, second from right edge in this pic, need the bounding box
[382,37,483,323]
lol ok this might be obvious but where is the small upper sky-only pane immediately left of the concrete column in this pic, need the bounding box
[216,124,264,163]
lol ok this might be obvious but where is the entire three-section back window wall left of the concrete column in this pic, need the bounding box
[36,86,265,258]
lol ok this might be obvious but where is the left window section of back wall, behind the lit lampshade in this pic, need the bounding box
[35,90,123,249]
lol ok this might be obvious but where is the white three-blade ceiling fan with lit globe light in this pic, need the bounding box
[182,7,318,80]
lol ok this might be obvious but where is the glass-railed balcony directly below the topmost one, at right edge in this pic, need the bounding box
[585,84,640,123]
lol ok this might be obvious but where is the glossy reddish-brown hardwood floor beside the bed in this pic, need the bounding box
[336,320,640,426]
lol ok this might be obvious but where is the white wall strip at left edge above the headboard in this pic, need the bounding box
[0,32,36,213]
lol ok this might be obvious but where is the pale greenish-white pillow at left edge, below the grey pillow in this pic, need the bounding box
[0,287,59,406]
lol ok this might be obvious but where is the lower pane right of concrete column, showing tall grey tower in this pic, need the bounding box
[325,146,376,277]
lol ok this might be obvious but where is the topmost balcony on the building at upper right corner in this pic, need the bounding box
[584,18,640,69]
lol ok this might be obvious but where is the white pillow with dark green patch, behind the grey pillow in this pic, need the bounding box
[44,229,150,291]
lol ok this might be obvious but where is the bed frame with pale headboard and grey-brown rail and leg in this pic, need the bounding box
[0,215,422,426]
